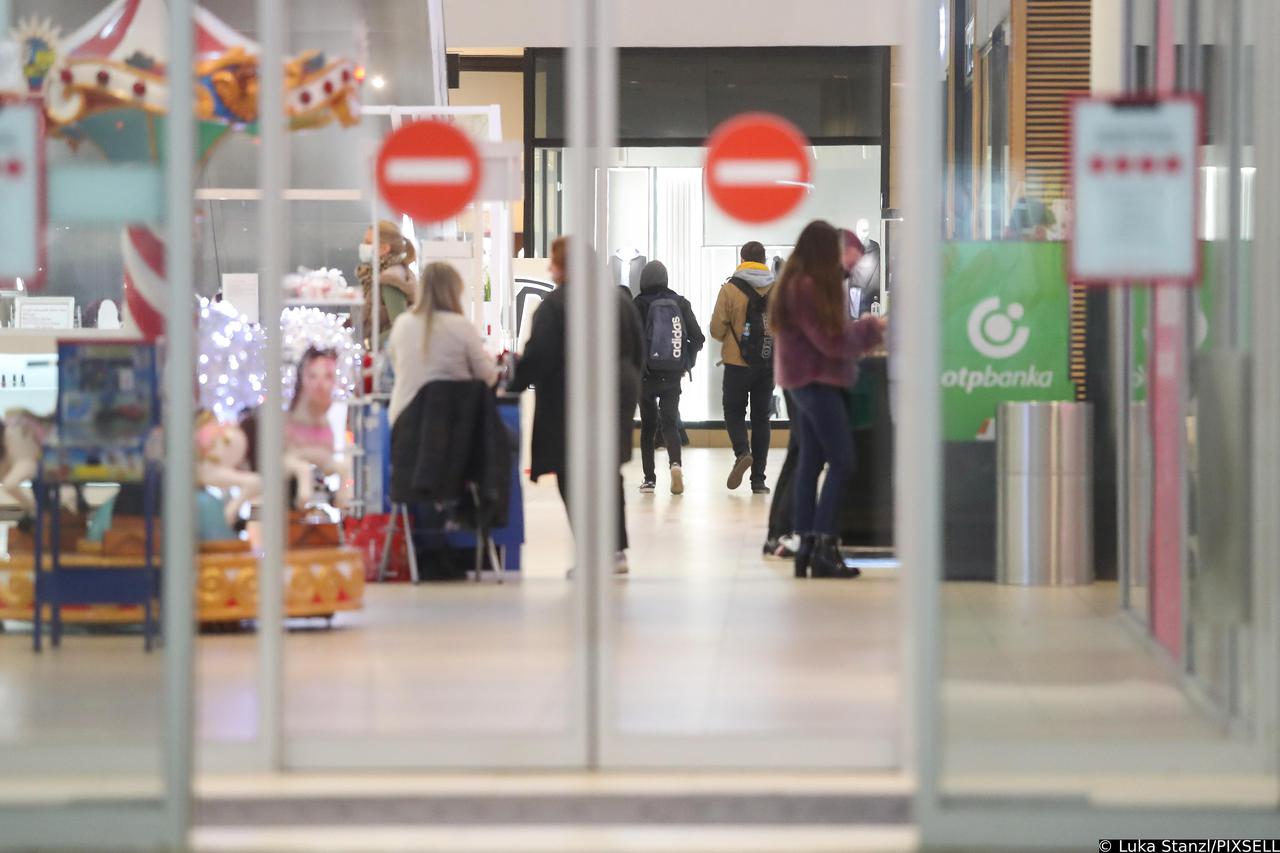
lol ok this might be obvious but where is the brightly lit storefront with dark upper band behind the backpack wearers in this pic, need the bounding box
[526,47,888,423]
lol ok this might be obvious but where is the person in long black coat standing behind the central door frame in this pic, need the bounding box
[508,237,644,574]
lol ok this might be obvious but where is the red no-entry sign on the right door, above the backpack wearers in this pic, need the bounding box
[707,113,812,223]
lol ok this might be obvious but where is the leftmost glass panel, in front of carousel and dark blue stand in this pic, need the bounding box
[0,0,197,849]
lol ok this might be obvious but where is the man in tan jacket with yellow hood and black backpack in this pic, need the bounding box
[712,241,773,494]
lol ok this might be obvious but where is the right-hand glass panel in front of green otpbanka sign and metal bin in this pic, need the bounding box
[911,1,1280,849]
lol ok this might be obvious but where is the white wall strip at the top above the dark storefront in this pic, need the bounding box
[444,0,904,49]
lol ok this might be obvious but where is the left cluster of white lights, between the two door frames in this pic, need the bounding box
[196,298,266,421]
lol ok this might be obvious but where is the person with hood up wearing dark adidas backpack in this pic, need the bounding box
[636,261,707,494]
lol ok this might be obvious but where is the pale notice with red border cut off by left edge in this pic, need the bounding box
[0,104,45,281]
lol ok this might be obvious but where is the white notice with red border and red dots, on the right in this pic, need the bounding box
[1070,97,1201,283]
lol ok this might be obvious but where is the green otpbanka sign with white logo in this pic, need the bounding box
[941,242,1075,441]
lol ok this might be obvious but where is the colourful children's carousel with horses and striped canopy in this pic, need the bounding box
[0,0,367,622]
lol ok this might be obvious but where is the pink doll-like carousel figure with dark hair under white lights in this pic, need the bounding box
[284,348,351,508]
